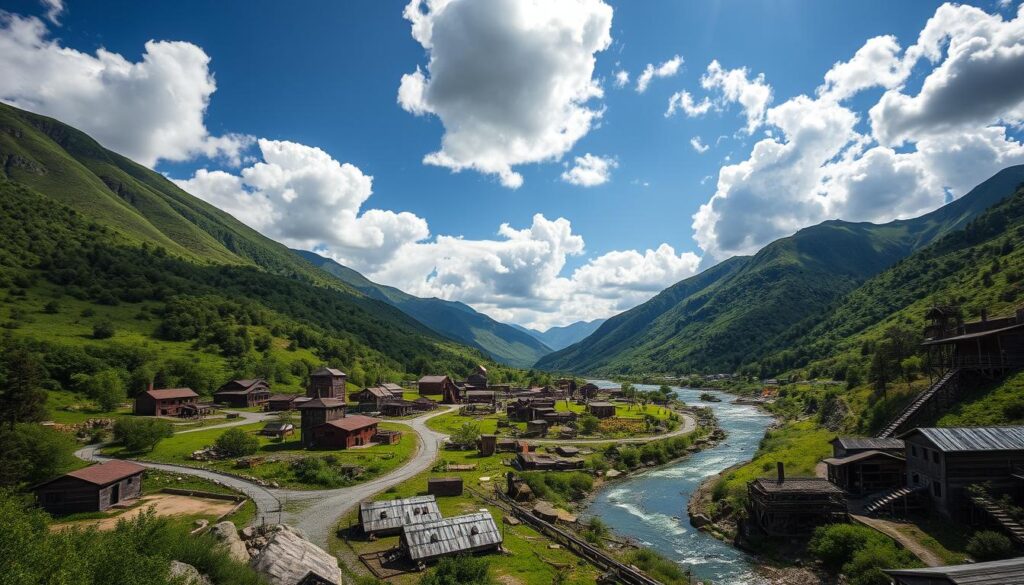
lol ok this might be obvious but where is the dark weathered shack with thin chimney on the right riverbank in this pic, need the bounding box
[746,463,847,536]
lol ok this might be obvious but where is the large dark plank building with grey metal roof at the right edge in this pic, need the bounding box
[900,426,1024,515]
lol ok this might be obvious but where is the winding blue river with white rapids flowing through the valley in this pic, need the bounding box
[586,380,772,585]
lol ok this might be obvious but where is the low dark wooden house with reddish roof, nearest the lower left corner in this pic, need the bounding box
[33,460,145,515]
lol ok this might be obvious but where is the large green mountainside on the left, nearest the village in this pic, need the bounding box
[0,105,507,390]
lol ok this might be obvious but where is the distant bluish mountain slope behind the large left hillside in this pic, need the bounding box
[294,250,551,368]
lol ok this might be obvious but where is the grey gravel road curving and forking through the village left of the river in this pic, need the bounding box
[75,406,458,549]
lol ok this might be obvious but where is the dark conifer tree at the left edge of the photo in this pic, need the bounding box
[0,348,46,430]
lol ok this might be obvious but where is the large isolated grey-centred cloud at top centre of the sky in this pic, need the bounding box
[398,0,612,189]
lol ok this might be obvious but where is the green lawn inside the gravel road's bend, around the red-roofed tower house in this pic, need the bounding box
[105,423,419,490]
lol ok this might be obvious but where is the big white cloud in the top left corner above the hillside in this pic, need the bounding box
[0,12,251,167]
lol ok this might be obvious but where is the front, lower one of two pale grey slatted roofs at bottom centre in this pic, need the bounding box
[402,512,502,561]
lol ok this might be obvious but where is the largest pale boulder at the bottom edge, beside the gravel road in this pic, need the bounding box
[250,526,342,585]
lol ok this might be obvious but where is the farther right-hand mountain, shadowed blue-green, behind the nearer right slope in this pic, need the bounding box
[538,166,1024,375]
